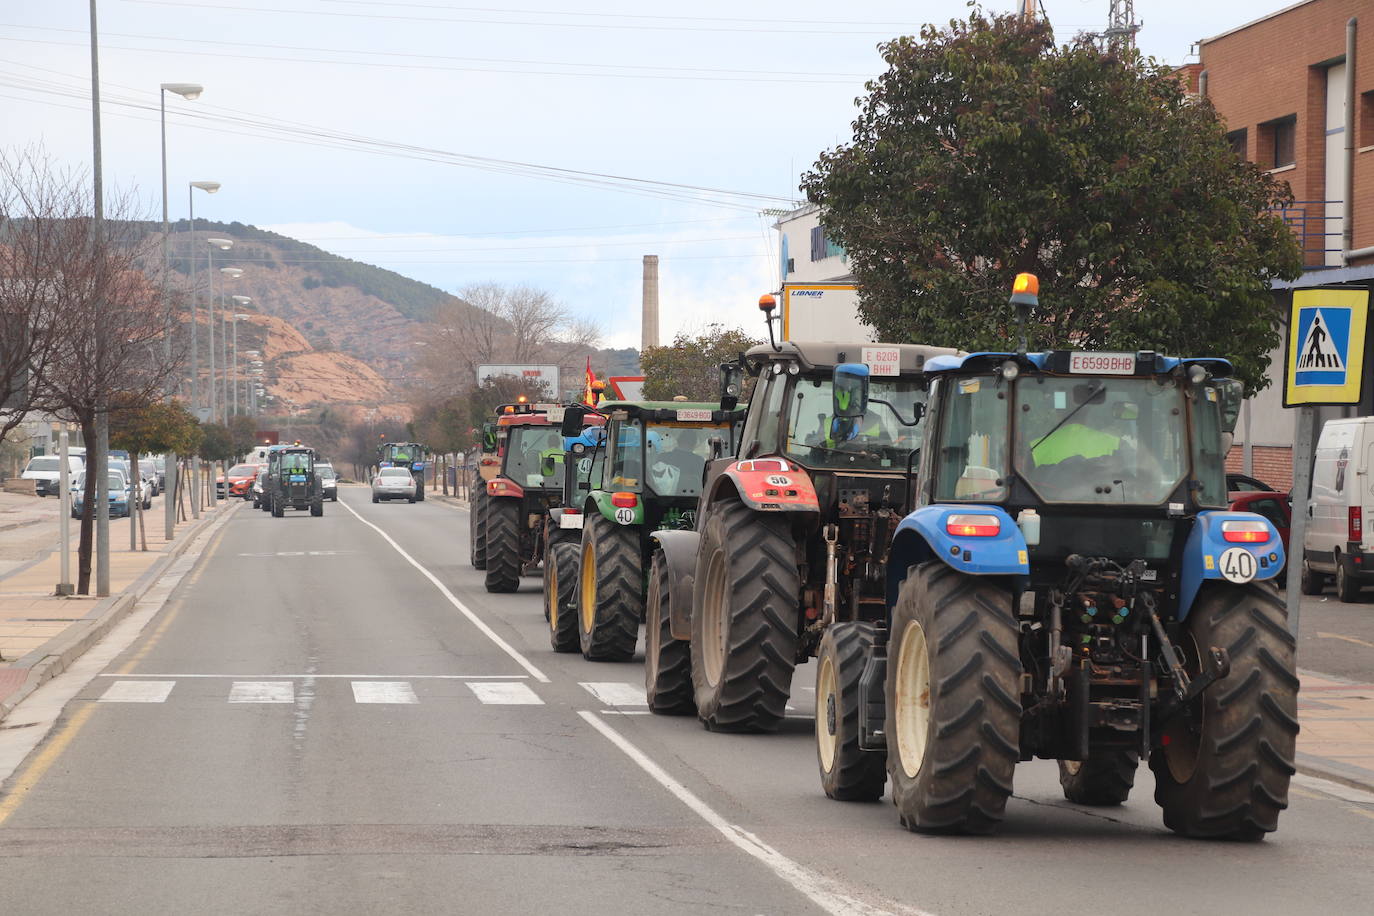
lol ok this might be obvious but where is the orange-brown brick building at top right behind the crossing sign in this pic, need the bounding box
[1184,0,1374,488]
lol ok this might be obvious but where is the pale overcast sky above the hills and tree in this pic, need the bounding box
[0,0,1289,346]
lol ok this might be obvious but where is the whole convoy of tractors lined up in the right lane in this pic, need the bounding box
[461,281,1298,840]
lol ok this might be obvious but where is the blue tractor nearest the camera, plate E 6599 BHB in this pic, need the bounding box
[816,275,1298,839]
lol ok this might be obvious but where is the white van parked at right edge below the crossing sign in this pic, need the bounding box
[1303,416,1374,602]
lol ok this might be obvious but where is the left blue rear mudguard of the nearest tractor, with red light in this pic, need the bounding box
[888,505,1031,610]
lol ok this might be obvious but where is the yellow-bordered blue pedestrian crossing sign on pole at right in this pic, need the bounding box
[1283,288,1370,407]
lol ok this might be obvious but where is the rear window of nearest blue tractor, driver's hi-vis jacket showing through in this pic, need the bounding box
[1014,376,1192,505]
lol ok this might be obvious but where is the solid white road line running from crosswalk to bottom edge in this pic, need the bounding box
[577,710,930,916]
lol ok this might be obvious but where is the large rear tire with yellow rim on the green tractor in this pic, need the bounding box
[577,509,644,662]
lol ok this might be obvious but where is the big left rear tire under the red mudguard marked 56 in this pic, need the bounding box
[691,500,801,732]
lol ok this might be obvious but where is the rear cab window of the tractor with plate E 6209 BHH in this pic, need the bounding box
[783,376,926,470]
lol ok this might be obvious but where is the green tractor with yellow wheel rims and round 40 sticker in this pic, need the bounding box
[550,401,745,661]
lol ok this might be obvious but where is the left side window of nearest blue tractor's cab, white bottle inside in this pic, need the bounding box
[933,375,1007,501]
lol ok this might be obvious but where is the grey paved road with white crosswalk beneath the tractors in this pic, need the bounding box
[0,488,1374,916]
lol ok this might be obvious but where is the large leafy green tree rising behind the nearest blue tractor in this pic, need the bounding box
[801,11,1301,390]
